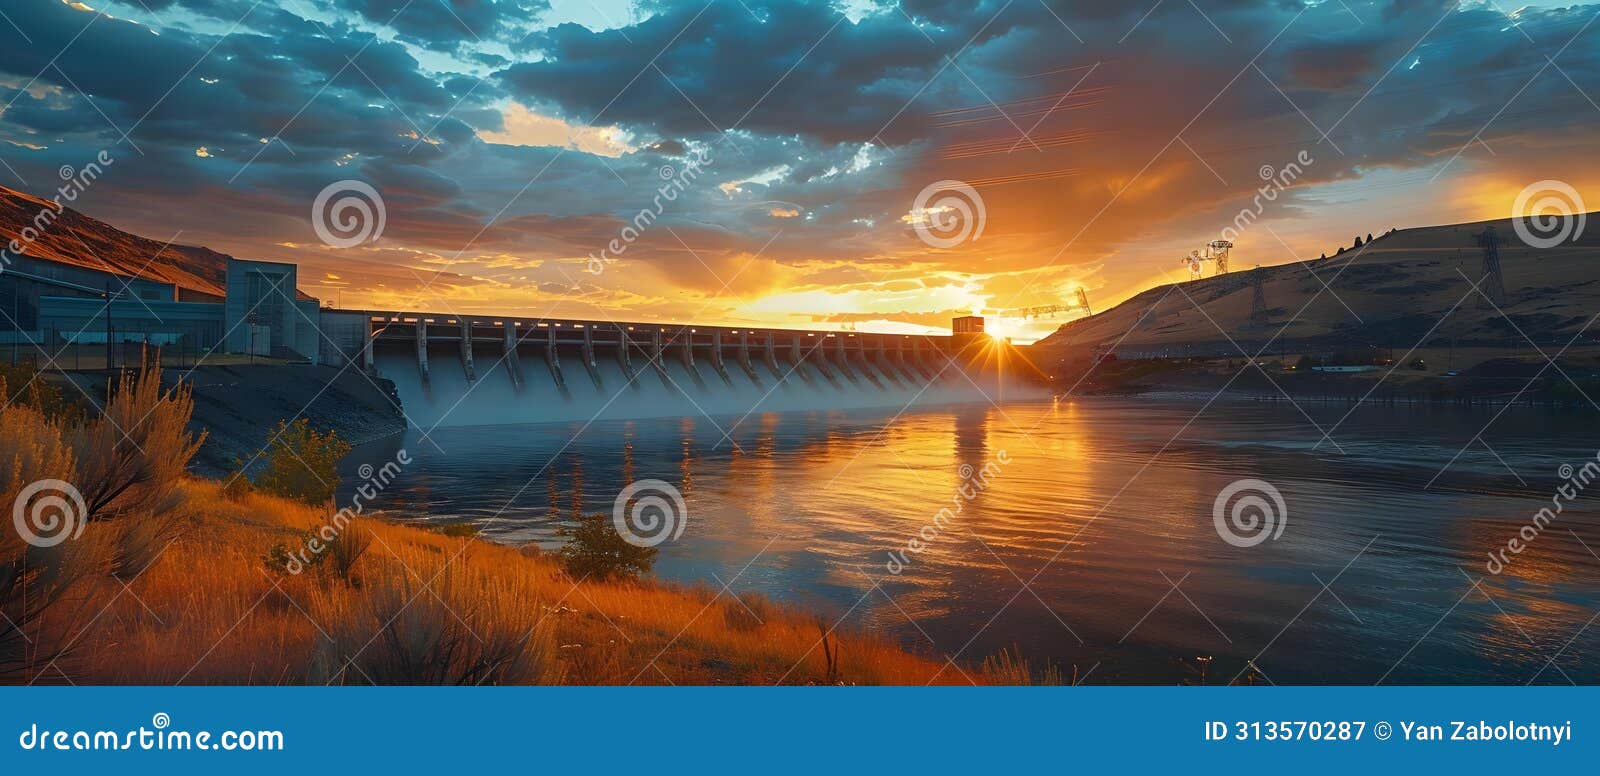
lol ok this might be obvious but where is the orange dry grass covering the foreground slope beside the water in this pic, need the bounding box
[24,480,966,685]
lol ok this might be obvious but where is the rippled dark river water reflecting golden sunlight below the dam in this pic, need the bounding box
[347,400,1600,685]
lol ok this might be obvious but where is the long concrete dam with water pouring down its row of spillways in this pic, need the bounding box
[350,310,1048,429]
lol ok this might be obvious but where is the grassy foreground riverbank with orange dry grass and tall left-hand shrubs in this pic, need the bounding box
[0,364,966,685]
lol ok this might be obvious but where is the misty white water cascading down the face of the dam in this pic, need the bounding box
[374,342,1046,430]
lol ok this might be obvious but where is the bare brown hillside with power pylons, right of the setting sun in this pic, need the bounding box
[1035,213,1600,360]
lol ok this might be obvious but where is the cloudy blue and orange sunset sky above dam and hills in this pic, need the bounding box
[0,0,1600,341]
